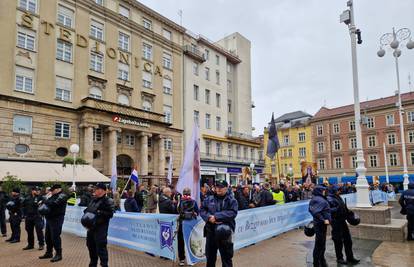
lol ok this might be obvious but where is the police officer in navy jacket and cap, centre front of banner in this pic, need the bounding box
[200,180,238,267]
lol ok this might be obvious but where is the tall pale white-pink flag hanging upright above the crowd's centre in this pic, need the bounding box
[176,123,200,204]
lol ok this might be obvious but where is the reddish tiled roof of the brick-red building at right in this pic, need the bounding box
[313,92,414,120]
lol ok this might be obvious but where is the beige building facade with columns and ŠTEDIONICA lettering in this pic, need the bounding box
[0,0,185,183]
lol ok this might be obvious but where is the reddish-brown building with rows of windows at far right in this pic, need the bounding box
[311,92,414,183]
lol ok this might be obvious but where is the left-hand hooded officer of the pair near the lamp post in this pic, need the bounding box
[309,185,331,267]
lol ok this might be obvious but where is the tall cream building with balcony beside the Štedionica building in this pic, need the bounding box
[183,31,263,184]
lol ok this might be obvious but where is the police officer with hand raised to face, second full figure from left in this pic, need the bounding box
[39,184,67,262]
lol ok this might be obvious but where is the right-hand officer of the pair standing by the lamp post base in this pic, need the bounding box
[328,185,359,264]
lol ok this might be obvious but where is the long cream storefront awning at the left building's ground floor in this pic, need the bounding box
[0,161,110,183]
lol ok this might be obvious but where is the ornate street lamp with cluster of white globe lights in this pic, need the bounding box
[377,28,414,190]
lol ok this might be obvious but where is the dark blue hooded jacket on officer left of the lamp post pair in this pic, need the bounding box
[309,185,331,223]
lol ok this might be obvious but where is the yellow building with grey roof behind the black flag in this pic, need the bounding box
[264,111,312,183]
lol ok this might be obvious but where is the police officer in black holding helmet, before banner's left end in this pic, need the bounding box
[84,183,115,267]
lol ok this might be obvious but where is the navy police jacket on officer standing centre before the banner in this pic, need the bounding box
[200,192,238,232]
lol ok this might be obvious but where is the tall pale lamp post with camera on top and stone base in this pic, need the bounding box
[340,0,371,208]
